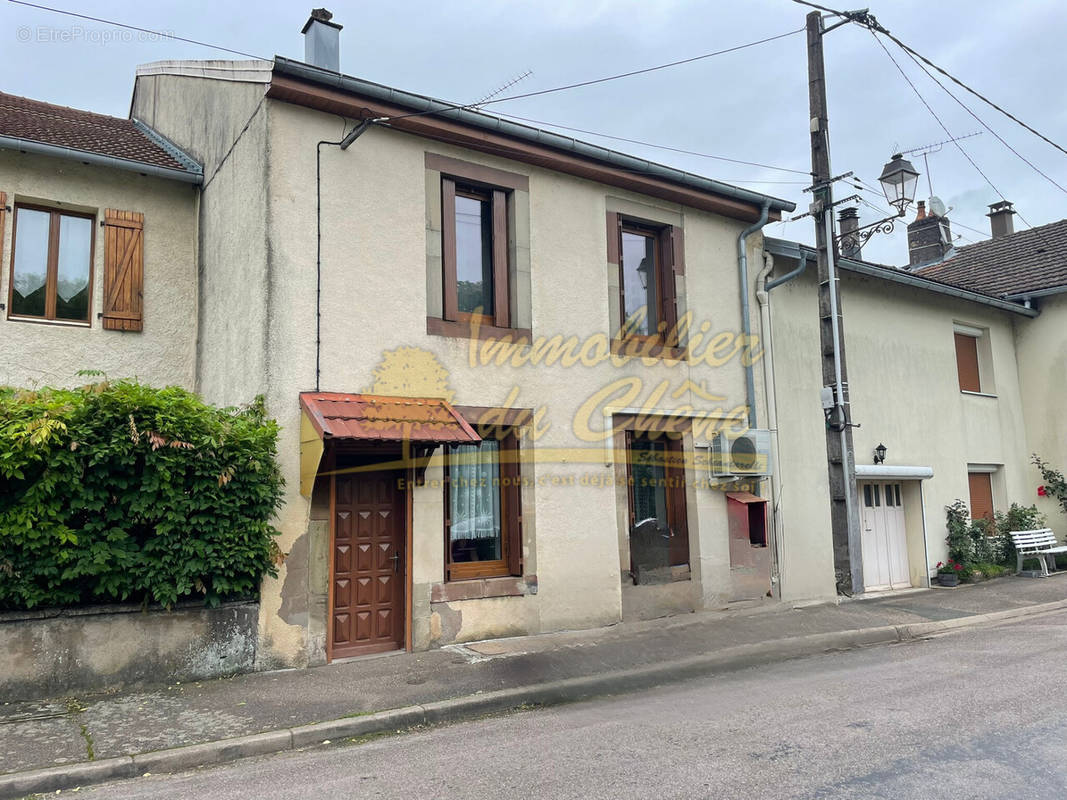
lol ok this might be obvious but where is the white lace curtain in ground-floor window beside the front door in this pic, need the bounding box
[448,439,500,542]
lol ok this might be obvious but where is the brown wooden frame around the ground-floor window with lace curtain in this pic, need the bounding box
[444,428,523,582]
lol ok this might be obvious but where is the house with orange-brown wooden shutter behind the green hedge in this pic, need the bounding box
[0,93,202,388]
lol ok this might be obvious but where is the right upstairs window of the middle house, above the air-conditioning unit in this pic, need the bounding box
[608,211,684,348]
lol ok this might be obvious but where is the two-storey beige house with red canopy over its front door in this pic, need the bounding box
[132,12,815,665]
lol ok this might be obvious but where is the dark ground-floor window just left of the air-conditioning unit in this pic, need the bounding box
[626,431,689,583]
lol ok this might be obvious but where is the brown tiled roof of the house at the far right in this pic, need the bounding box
[915,220,1067,297]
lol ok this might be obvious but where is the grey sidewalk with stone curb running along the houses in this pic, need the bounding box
[0,575,1067,798]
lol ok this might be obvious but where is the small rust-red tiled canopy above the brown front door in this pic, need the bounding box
[300,391,481,443]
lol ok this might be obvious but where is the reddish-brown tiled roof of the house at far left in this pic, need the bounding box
[0,92,198,172]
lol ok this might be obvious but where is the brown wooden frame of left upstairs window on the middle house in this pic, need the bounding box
[441,175,511,329]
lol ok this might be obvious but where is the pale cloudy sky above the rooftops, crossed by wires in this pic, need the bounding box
[0,0,1067,265]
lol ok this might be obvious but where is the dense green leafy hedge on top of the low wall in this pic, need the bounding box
[0,381,282,609]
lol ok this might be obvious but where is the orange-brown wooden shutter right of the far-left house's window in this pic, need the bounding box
[103,208,144,331]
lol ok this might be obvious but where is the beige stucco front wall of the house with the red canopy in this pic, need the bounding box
[251,97,785,658]
